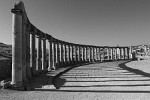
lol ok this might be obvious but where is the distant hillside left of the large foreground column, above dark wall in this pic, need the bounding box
[0,42,12,58]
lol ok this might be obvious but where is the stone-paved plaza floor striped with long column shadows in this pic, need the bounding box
[0,61,150,100]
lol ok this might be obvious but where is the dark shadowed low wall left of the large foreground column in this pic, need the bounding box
[0,59,12,79]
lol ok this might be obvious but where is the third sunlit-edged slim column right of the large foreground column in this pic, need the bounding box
[42,34,46,71]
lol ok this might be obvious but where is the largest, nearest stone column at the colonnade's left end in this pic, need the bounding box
[11,9,23,87]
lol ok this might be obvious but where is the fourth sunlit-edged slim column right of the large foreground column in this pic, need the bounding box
[48,38,53,71]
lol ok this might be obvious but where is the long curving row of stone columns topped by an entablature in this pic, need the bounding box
[11,1,131,87]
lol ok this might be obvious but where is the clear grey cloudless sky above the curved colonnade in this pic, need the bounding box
[0,0,150,46]
